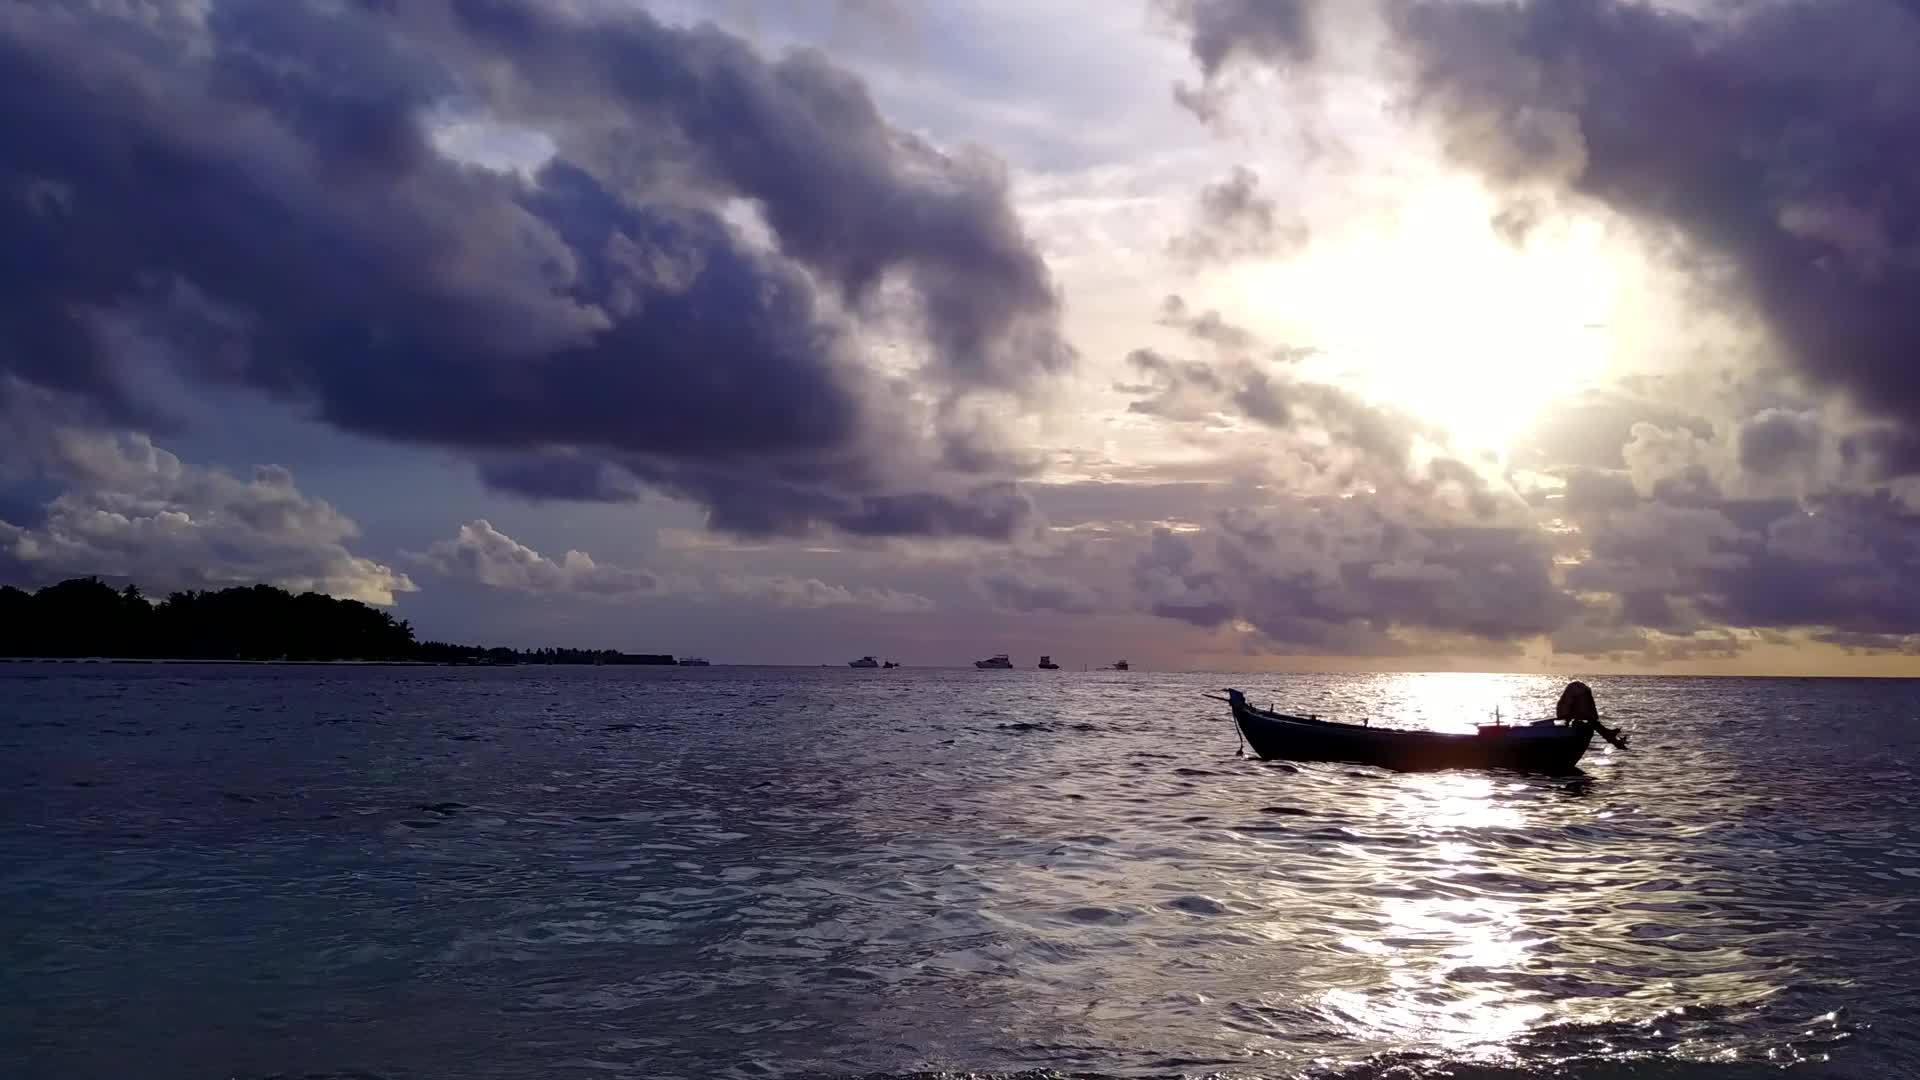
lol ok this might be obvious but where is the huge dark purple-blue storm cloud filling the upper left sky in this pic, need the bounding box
[0,0,1071,536]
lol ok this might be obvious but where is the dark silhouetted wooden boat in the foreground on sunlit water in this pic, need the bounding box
[1227,684,1626,774]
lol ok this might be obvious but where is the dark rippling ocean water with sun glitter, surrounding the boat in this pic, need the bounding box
[0,665,1920,1080]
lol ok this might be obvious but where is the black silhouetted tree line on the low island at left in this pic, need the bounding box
[0,577,674,663]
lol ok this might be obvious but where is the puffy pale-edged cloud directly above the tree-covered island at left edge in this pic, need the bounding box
[0,417,415,605]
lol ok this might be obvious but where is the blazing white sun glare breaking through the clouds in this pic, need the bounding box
[1236,172,1624,455]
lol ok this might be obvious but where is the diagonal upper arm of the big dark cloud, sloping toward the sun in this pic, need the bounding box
[422,0,1071,384]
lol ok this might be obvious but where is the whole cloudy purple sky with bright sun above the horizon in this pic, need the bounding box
[0,0,1920,675]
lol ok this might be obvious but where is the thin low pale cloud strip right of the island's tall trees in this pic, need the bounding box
[411,519,933,613]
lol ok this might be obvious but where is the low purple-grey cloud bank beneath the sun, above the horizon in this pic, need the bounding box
[1067,361,1920,665]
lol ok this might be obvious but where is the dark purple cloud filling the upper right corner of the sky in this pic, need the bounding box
[1159,0,1920,445]
